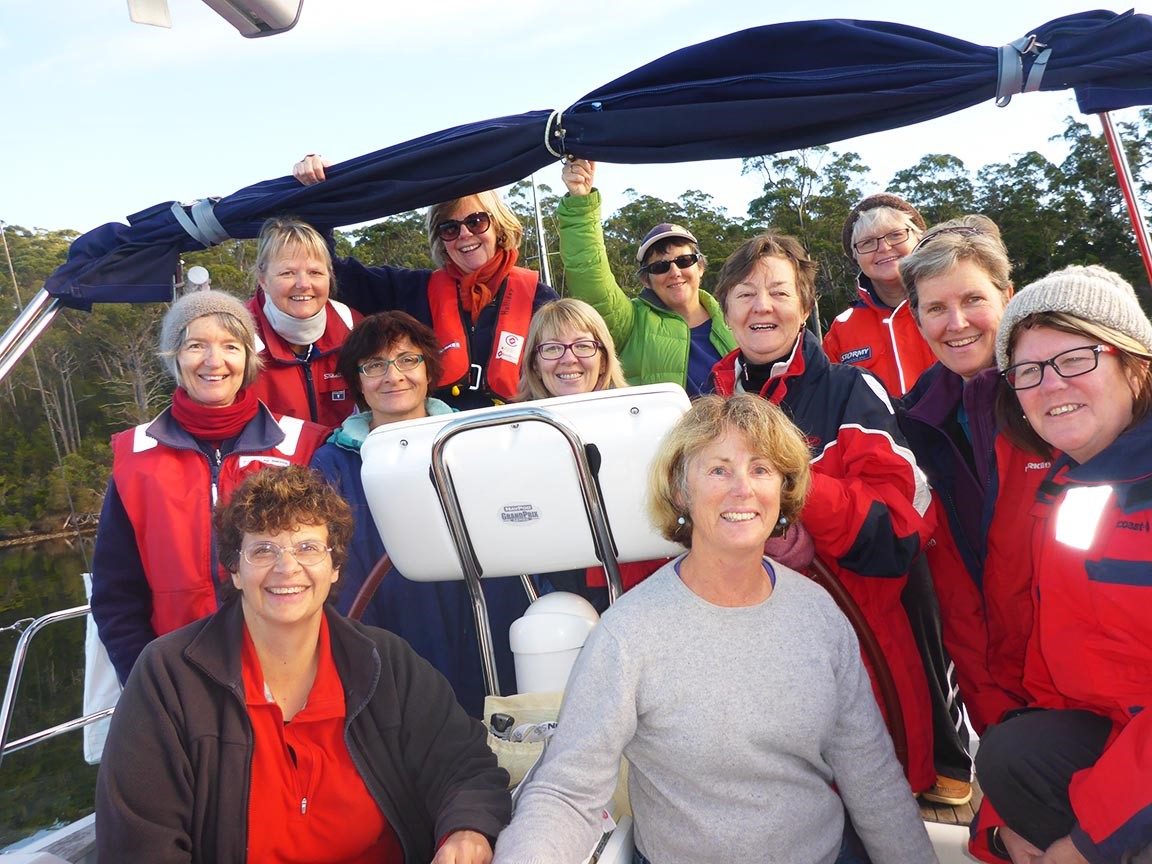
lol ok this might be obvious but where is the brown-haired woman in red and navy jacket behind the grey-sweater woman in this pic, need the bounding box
[712,234,935,791]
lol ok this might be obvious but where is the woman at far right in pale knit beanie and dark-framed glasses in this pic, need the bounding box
[976,266,1152,864]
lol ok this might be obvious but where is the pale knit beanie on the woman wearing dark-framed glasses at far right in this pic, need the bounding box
[996,264,1152,371]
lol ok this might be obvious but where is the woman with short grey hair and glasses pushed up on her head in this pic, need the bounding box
[897,215,1043,734]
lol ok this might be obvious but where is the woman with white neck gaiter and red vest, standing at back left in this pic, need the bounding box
[245,219,362,427]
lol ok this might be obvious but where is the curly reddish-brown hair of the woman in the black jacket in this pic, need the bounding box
[212,465,353,601]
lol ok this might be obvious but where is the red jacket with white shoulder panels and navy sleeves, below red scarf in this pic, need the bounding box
[92,406,327,681]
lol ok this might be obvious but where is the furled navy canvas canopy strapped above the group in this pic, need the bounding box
[45,12,1152,309]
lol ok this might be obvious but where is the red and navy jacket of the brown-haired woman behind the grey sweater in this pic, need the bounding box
[712,331,935,791]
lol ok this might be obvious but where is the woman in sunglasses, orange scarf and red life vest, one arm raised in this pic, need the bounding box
[293,154,558,410]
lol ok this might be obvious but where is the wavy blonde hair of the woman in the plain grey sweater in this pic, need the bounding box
[647,393,811,547]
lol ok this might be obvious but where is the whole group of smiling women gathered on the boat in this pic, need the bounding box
[92,157,1152,864]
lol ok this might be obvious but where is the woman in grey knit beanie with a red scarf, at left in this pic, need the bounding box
[92,291,327,682]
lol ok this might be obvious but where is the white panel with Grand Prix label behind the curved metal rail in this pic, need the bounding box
[361,384,689,582]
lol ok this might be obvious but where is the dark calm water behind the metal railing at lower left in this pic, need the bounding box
[0,540,96,850]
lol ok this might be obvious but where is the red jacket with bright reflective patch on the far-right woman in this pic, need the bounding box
[1024,419,1152,864]
